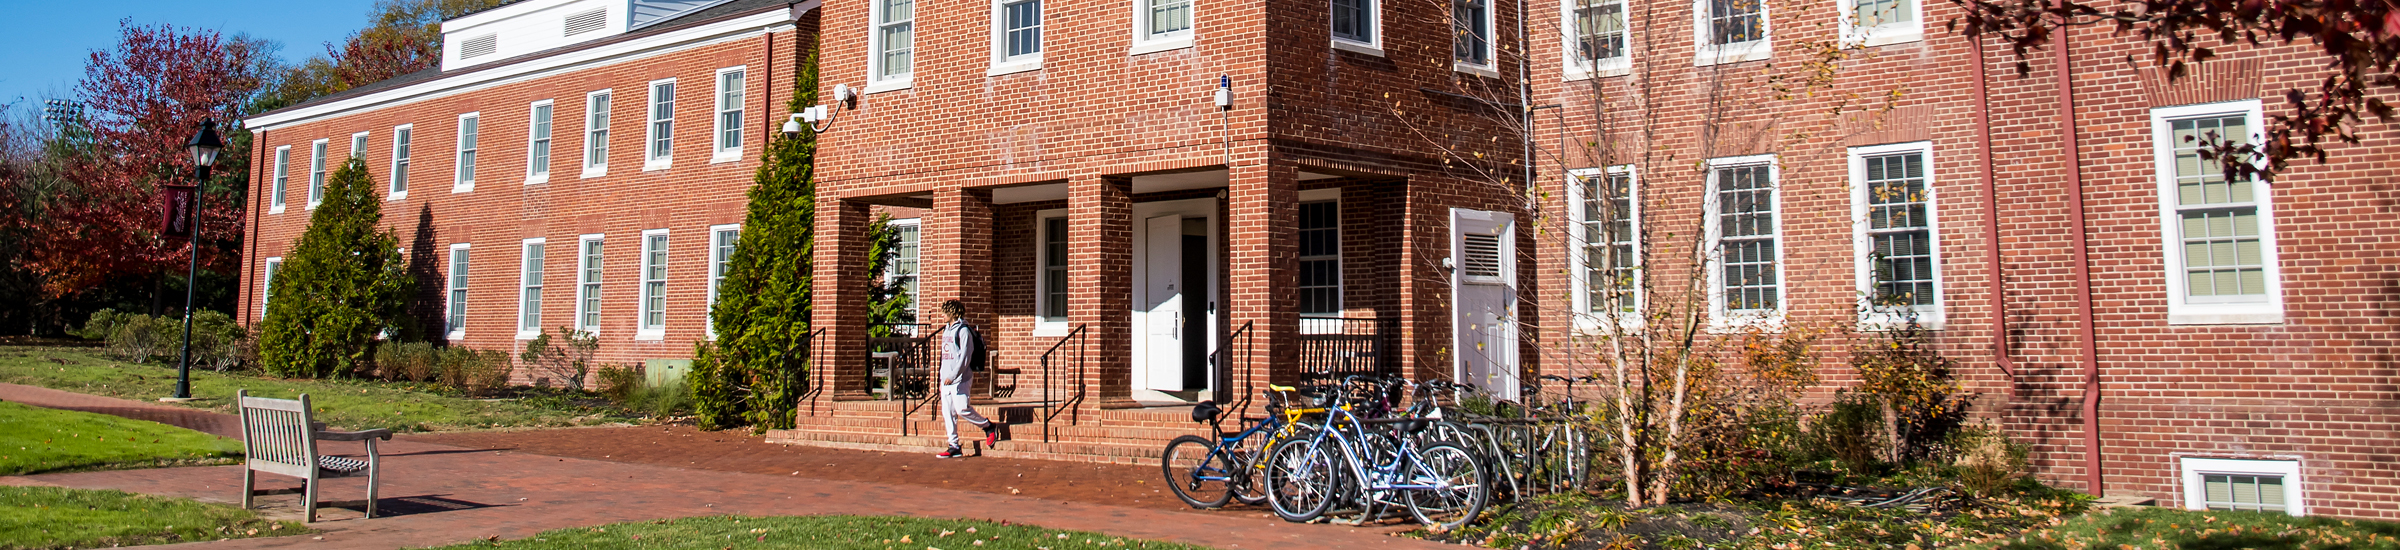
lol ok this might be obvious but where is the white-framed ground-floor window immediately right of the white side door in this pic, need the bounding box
[1567,166,1642,331]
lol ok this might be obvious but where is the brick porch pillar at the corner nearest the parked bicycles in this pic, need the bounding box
[1226,156,1301,396]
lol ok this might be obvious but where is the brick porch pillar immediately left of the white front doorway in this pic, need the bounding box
[1066,175,1133,408]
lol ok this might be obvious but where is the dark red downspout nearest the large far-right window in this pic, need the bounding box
[2052,4,2107,497]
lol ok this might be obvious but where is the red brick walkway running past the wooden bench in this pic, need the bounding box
[0,384,1435,548]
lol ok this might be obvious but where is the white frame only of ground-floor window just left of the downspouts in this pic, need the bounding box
[1843,142,1951,329]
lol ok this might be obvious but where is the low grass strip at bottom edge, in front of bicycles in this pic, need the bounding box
[417,516,1219,550]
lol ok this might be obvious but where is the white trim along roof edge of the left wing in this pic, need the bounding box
[242,10,794,132]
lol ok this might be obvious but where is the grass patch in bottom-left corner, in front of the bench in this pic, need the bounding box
[0,488,307,550]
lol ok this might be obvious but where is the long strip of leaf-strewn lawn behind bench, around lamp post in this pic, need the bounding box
[0,346,626,432]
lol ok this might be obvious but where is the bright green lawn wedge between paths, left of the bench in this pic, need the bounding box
[0,401,242,476]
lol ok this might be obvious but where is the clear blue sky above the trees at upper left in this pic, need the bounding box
[0,0,372,106]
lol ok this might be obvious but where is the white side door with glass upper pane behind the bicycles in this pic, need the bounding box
[1450,209,1519,399]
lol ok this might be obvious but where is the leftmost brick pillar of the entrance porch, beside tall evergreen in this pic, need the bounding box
[811,197,869,401]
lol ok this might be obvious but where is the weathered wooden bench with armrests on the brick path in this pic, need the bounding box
[238,389,391,521]
